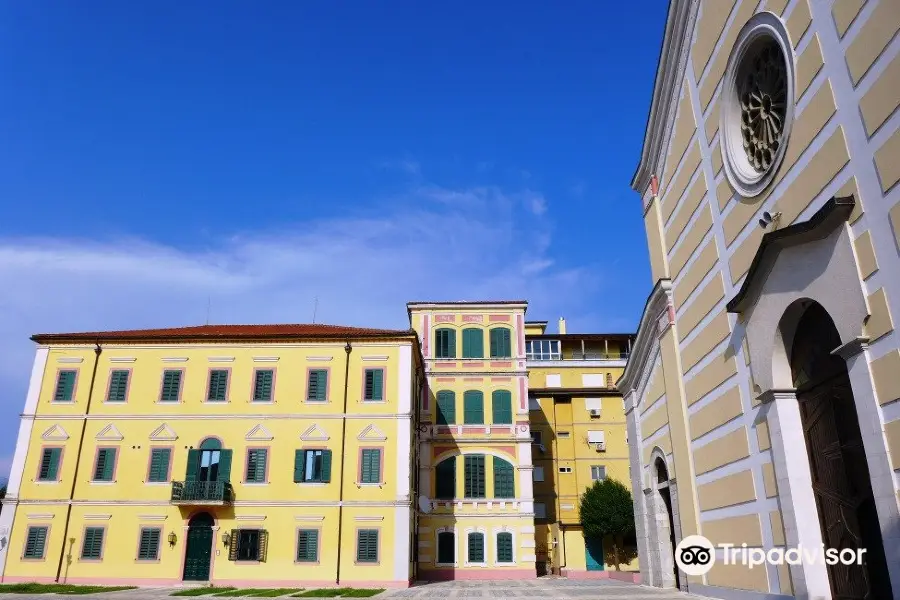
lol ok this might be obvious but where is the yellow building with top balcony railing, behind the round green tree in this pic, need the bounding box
[525,319,637,578]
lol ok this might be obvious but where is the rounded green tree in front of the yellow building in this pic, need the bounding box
[579,477,634,571]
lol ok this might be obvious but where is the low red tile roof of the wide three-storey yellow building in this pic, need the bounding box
[31,323,416,343]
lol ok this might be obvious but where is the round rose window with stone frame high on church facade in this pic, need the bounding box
[719,12,794,197]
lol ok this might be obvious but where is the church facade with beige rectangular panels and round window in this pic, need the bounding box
[618,0,900,599]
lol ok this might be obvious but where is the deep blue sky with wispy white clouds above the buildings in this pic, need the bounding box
[0,0,666,473]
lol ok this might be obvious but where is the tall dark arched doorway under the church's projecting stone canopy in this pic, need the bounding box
[790,302,893,600]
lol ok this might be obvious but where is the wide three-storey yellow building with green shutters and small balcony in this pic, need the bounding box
[0,325,425,587]
